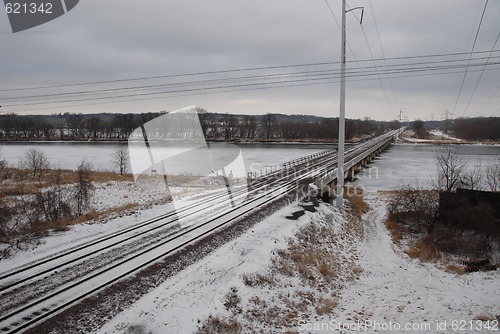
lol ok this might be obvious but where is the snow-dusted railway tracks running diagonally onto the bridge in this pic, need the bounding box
[0,130,396,333]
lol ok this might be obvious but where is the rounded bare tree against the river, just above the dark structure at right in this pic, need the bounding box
[436,146,467,192]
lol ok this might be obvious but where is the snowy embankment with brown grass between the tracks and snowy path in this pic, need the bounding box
[101,194,363,333]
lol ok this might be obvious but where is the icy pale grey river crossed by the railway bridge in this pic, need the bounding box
[0,142,500,191]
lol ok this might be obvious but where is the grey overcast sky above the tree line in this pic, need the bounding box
[0,0,500,120]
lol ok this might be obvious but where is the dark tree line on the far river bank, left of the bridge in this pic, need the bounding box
[0,108,399,141]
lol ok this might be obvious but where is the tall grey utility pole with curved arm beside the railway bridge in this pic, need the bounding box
[336,0,364,208]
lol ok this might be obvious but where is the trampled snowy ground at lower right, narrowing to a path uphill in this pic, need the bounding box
[335,193,500,333]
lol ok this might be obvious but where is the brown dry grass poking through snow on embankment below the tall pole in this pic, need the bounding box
[199,198,368,333]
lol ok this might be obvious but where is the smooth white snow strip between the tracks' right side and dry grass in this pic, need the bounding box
[100,201,314,333]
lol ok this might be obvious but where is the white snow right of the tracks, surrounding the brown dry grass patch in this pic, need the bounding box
[100,192,500,334]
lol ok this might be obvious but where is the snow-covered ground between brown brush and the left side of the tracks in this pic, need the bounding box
[0,178,222,272]
